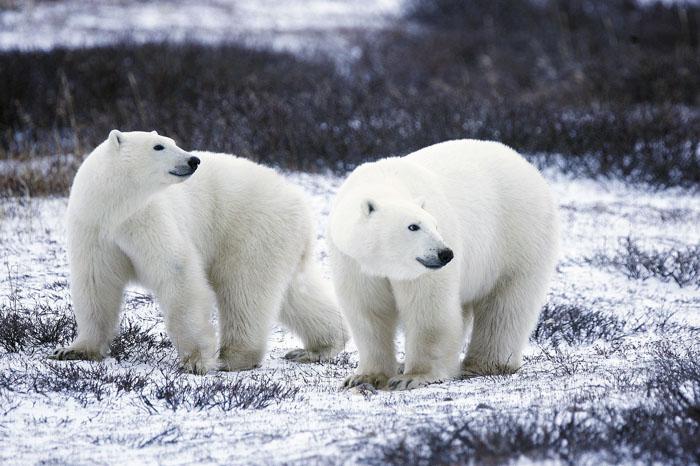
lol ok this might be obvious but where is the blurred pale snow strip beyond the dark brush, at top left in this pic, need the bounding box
[0,0,401,51]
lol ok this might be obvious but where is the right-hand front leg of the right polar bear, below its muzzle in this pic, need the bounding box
[387,272,463,390]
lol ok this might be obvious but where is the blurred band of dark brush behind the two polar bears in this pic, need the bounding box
[0,0,700,194]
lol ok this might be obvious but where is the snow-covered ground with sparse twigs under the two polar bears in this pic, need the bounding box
[0,169,700,464]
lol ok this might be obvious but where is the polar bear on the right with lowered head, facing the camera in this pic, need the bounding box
[329,140,559,390]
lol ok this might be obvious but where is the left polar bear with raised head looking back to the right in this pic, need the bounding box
[52,130,347,374]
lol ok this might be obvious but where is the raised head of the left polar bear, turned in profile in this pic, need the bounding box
[106,129,199,189]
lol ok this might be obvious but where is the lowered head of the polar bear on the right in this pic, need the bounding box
[330,198,454,280]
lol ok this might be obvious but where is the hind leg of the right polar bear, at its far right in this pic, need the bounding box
[462,278,546,376]
